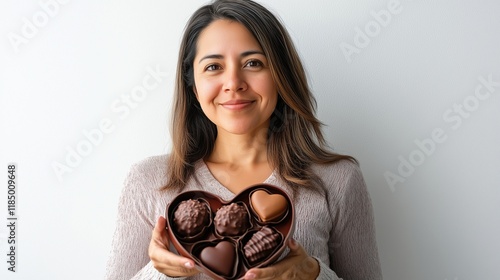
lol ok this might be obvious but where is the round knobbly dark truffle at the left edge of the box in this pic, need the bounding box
[174,199,210,238]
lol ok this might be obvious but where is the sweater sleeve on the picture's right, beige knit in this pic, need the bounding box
[320,161,382,280]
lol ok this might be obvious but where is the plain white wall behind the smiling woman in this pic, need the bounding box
[0,0,500,280]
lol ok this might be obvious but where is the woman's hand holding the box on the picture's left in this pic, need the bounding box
[149,217,199,277]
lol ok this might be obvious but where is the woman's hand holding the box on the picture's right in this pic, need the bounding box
[244,239,319,280]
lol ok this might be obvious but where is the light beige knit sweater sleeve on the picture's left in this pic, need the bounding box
[105,159,183,280]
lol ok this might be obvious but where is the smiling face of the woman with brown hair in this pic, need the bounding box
[193,20,278,134]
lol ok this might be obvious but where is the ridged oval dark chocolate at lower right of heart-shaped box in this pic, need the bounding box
[243,226,281,264]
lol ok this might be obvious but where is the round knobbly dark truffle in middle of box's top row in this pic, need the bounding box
[214,203,250,236]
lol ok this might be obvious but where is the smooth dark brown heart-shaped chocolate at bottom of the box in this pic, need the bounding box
[200,241,236,277]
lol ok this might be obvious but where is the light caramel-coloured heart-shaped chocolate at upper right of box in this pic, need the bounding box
[250,190,288,222]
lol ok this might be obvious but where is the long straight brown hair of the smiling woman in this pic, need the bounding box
[165,0,355,188]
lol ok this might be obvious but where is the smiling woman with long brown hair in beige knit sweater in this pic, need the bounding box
[107,0,382,280]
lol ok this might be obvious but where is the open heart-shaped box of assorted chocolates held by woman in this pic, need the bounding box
[165,184,295,280]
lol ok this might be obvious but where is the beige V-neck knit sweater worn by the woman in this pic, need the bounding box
[105,155,382,280]
